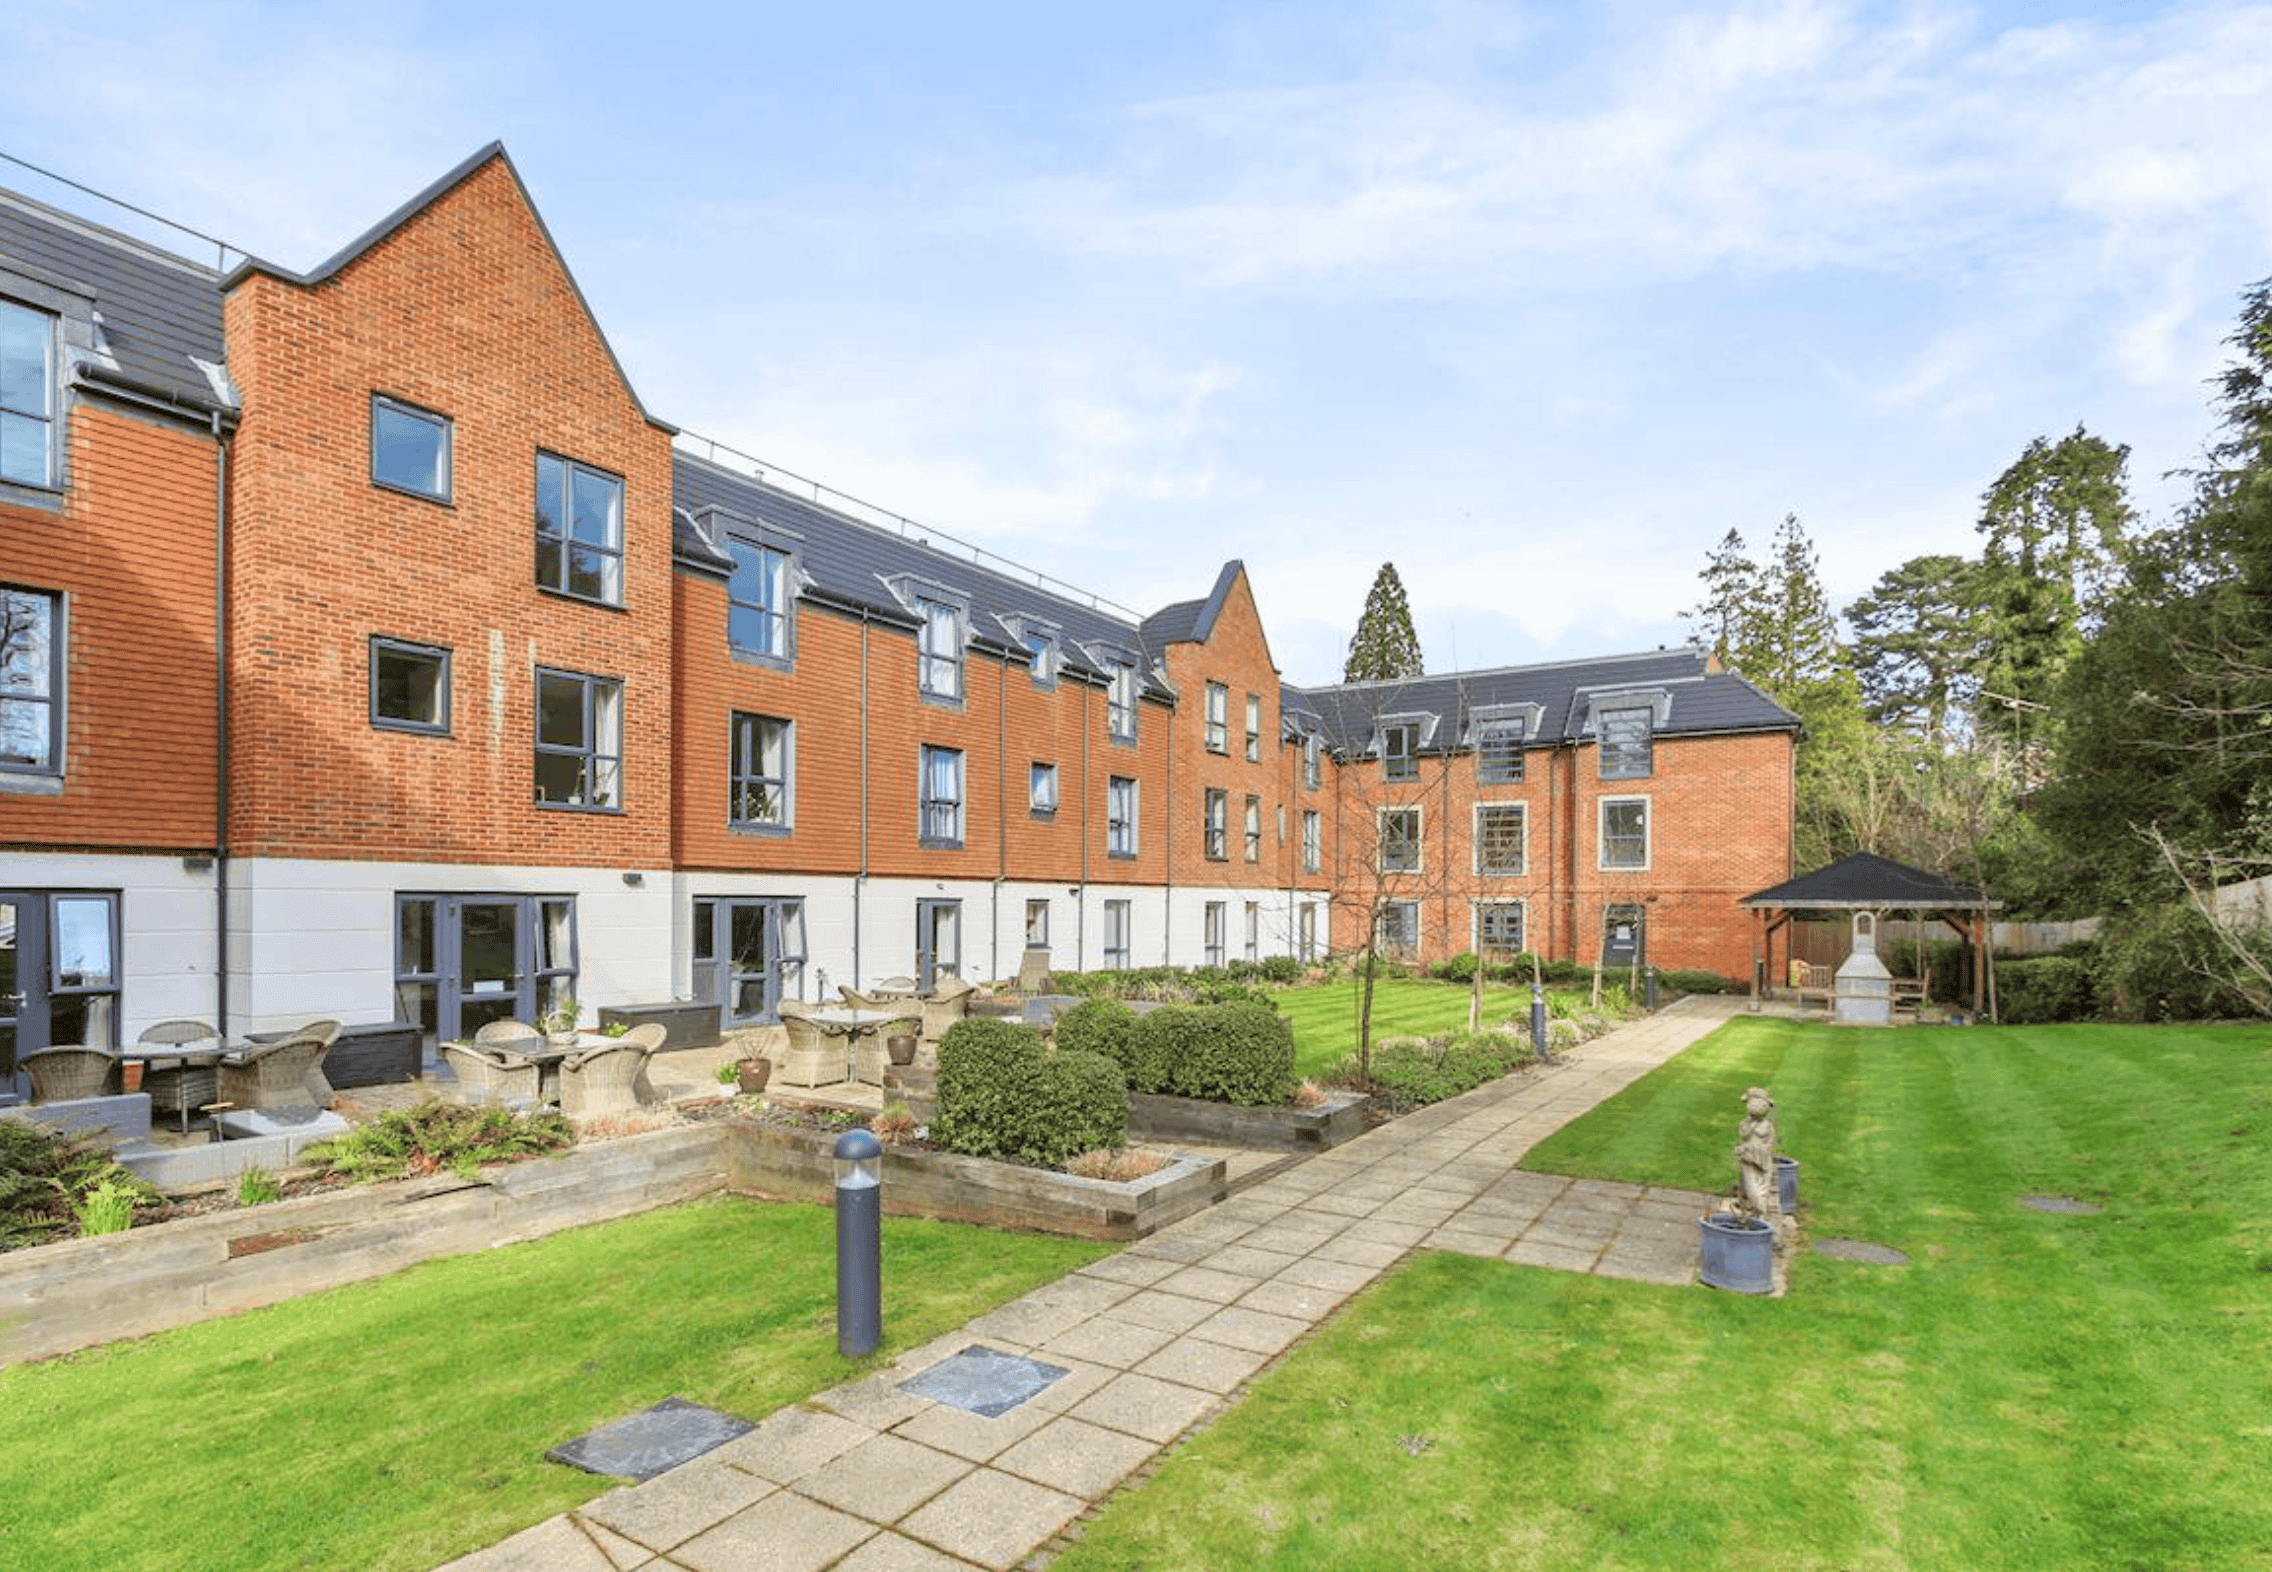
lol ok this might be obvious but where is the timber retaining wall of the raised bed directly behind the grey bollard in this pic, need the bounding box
[725,1120,1229,1240]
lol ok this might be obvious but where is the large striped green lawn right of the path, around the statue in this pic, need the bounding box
[1056,1020,2272,1572]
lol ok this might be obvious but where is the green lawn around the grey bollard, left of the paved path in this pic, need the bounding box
[0,1199,1109,1572]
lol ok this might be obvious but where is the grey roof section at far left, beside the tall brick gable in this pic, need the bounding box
[0,193,236,411]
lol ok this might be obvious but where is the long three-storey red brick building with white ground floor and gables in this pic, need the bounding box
[0,148,1797,1081]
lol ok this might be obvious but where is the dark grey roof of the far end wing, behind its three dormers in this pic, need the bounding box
[1286,647,1799,756]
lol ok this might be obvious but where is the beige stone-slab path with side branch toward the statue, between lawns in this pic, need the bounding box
[445,997,1740,1572]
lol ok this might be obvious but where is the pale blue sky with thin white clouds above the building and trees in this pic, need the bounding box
[0,0,2272,682]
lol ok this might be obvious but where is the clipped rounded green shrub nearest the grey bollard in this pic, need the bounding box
[932,1015,1129,1168]
